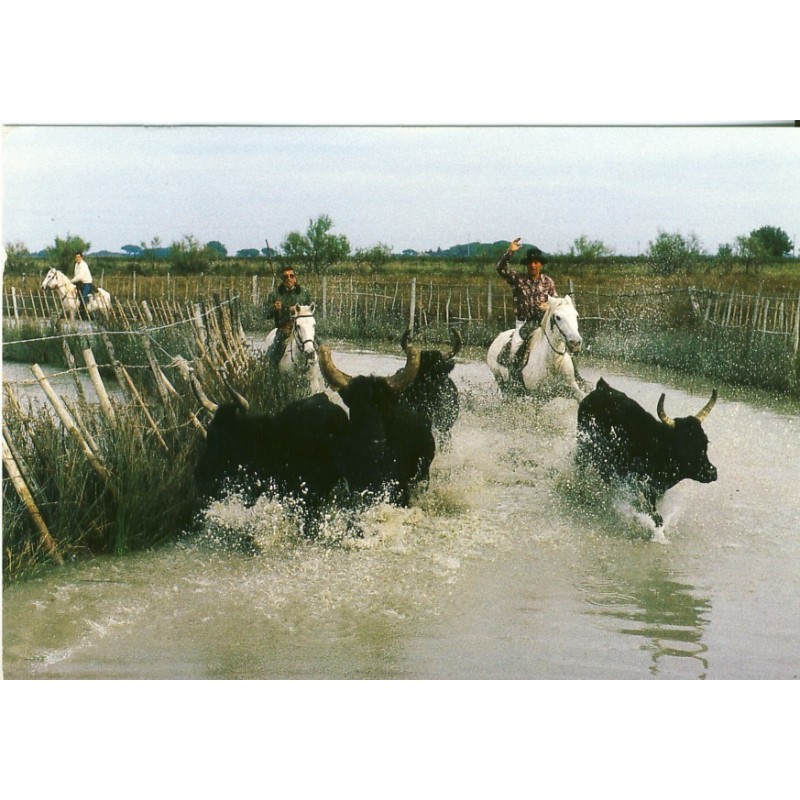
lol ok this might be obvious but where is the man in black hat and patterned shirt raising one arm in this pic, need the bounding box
[497,237,558,371]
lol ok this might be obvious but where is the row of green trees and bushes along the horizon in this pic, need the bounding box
[6,214,794,275]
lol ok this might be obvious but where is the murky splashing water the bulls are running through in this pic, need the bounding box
[3,351,800,679]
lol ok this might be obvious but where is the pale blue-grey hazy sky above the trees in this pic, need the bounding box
[2,124,800,255]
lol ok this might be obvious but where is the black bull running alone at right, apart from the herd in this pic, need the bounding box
[577,378,717,527]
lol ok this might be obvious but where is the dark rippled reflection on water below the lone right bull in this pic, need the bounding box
[582,567,711,679]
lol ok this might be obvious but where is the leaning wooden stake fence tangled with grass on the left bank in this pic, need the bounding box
[2,295,278,579]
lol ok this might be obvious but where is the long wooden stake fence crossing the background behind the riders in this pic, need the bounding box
[2,275,800,355]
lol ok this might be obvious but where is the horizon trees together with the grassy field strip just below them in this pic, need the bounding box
[5,219,797,278]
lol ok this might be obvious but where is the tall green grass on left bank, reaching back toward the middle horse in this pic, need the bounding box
[3,334,312,583]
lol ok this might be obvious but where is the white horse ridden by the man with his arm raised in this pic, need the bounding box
[486,295,591,401]
